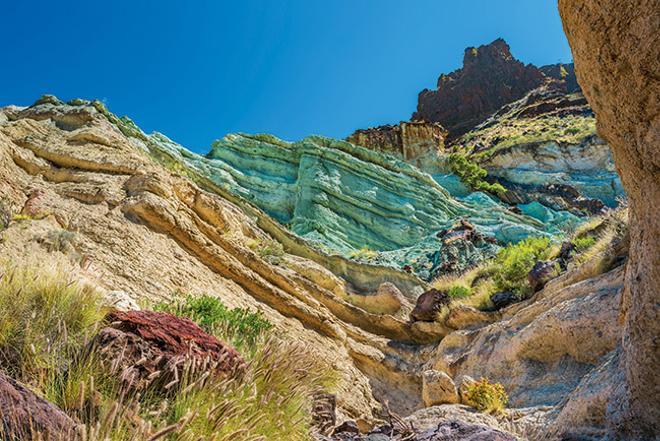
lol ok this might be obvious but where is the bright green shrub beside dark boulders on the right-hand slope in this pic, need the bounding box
[493,237,552,296]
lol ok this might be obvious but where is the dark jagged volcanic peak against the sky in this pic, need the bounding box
[412,39,546,137]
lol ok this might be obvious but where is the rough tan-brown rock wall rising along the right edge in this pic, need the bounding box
[559,0,660,440]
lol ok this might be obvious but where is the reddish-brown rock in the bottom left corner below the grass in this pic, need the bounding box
[0,373,78,441]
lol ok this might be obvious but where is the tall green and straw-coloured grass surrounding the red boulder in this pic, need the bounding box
[0,265,335,441]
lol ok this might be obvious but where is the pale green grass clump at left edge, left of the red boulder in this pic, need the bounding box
[0,264,107,380]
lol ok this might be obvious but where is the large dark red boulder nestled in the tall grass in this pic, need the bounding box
[94,311,245,389]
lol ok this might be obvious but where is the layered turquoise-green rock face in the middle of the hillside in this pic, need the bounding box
[151,129,576,267]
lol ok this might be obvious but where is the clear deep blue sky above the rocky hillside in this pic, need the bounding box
[0,0,571,152]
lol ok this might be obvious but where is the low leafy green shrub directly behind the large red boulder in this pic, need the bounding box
[154,295,273,352]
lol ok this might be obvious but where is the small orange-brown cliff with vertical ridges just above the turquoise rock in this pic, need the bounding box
[346,121,447,167]
